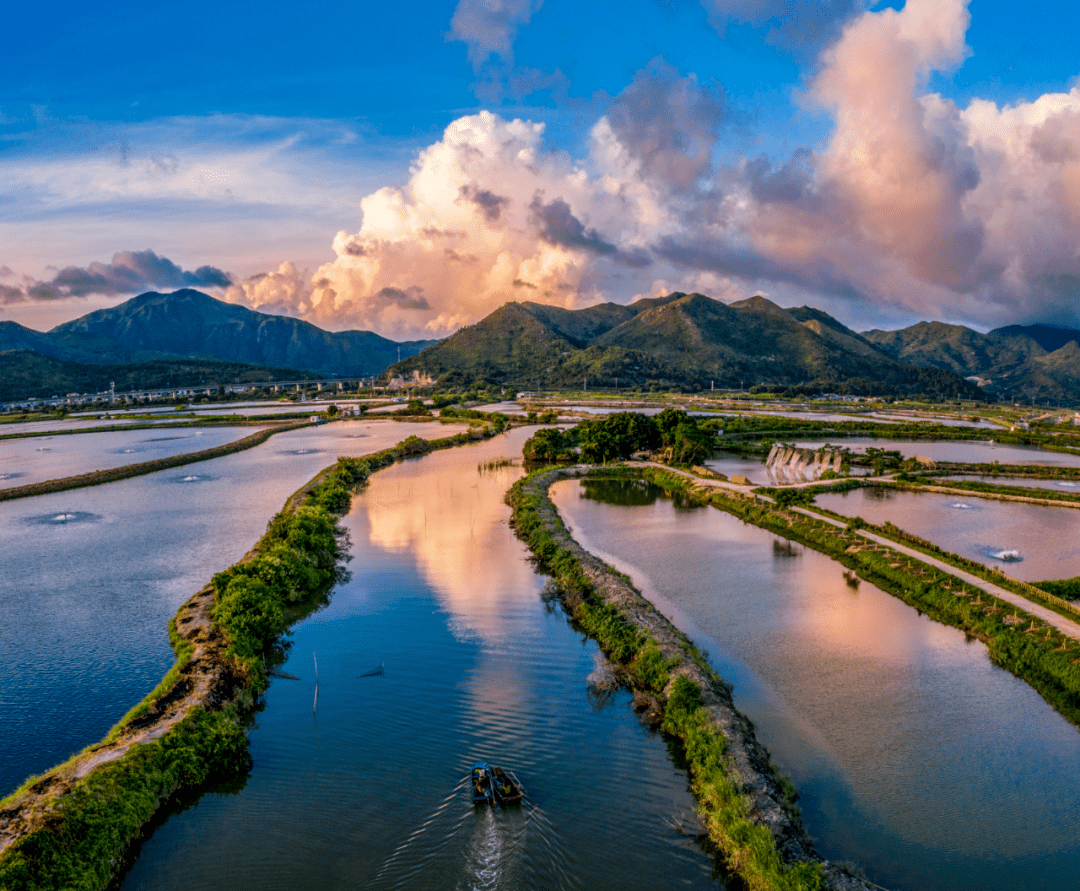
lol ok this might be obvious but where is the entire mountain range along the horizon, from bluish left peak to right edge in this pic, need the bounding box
[6,289,1080,404]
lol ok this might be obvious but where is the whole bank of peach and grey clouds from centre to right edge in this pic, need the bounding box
[235,0,1080,337]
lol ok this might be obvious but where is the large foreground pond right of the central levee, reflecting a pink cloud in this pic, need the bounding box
[554,482,1080,891]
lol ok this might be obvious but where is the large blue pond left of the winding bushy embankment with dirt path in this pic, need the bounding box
[0,420,447,796]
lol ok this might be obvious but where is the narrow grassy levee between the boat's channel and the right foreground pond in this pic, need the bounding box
[507,469,868,891]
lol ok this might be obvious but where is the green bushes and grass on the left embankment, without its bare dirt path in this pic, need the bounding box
[0,428,495,891]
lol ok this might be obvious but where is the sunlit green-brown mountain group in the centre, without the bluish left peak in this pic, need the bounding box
[388,293,978,399]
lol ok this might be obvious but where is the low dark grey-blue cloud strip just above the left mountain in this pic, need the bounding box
[8,251,230,302]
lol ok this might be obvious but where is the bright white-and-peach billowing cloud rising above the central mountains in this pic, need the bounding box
[282,112,673,337]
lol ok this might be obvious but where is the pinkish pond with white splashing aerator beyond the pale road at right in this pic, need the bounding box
[815,487,1080,582]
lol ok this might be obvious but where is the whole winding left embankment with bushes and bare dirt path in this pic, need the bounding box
[0,427,497,891]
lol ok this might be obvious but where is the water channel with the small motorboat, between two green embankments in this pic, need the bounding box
[122,429,723,891]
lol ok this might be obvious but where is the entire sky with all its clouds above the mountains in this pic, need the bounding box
[6,0,1080,336]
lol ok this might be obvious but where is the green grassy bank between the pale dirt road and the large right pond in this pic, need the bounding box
[646,471,1080,727]
